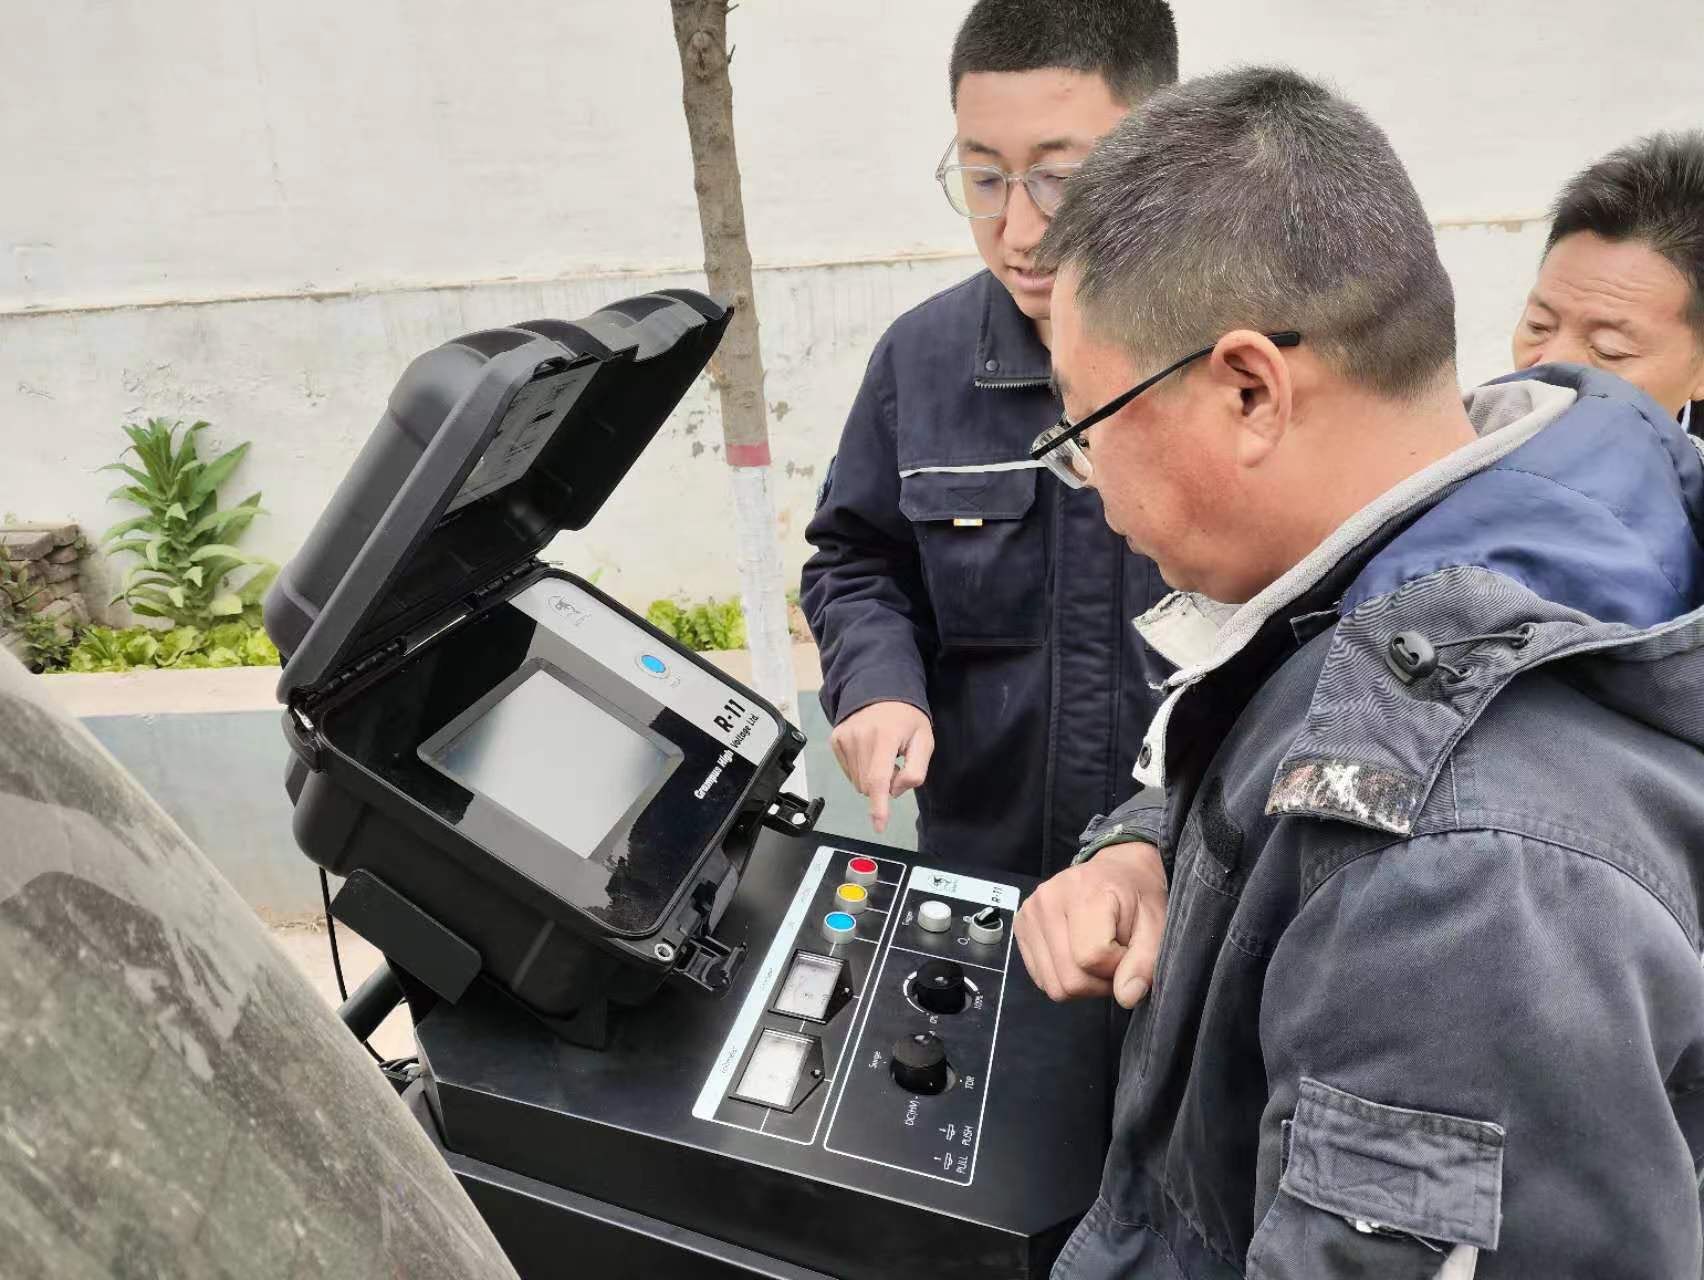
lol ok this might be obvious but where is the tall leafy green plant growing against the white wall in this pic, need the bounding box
[101,418,278,629]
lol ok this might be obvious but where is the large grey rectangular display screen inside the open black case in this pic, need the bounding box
[421,668,678,857]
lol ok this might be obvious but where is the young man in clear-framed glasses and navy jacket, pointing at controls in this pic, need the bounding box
[803,0,1177,874]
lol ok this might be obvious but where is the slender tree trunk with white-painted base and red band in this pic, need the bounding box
[670,0,809,794]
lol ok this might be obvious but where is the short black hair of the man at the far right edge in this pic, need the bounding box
[1544,130,1704,339]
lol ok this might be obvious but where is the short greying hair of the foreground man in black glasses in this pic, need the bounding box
[1038,66,1455,399]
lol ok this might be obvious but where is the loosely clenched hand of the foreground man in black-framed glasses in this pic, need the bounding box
[1012,840,1166,1009]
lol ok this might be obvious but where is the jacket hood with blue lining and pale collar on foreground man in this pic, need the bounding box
[1137,365,1704,833]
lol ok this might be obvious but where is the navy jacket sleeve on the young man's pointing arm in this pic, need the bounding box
[799,339,935,724]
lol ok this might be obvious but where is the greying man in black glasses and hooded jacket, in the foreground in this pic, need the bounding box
[1014,68,1704,1280]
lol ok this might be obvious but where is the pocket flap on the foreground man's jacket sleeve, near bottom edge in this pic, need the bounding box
[1281,1079,1505,1249]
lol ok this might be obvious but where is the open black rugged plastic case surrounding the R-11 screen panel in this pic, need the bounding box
[266,290,808,1040]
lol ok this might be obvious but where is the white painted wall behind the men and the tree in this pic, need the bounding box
[0,0,1704,605]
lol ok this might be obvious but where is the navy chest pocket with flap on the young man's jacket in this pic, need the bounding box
[900,469,1048,648]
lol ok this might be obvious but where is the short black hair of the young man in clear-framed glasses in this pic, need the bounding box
[947,0,1177,106]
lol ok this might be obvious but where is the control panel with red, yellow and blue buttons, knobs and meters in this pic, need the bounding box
[692,845,1019,1186]
